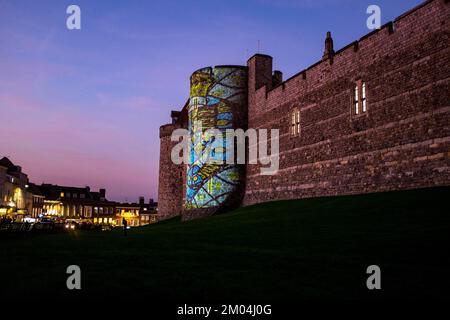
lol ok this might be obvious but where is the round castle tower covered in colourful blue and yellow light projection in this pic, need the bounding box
[185,66,247,209]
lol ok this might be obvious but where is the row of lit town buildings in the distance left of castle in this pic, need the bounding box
[0,157,157,226]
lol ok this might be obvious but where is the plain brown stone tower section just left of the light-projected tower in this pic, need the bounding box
[158,124,185,220]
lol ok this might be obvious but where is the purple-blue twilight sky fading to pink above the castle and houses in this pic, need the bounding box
[0,0,421,201]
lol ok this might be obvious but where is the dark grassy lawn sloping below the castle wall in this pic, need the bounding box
[0,187,450,302]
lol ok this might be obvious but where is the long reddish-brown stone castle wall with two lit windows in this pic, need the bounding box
[244,0,450,205]
